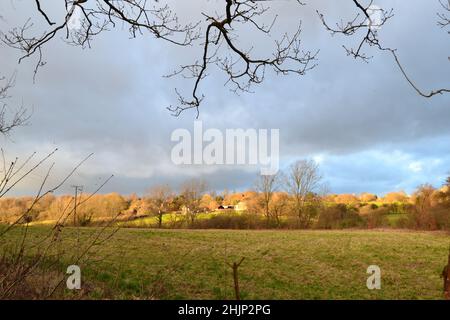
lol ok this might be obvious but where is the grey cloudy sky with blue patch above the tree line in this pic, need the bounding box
[0,0,450,194]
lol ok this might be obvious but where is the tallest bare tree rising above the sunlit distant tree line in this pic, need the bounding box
[286,160,322,228]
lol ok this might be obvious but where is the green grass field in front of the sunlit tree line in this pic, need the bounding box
[1,226,450,299]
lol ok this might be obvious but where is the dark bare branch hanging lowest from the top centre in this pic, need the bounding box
[168,0,317,117]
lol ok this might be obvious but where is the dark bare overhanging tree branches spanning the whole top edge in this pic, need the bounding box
[1,0,450,115]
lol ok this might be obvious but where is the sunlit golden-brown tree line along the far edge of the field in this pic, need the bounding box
[0,160,450,230]
